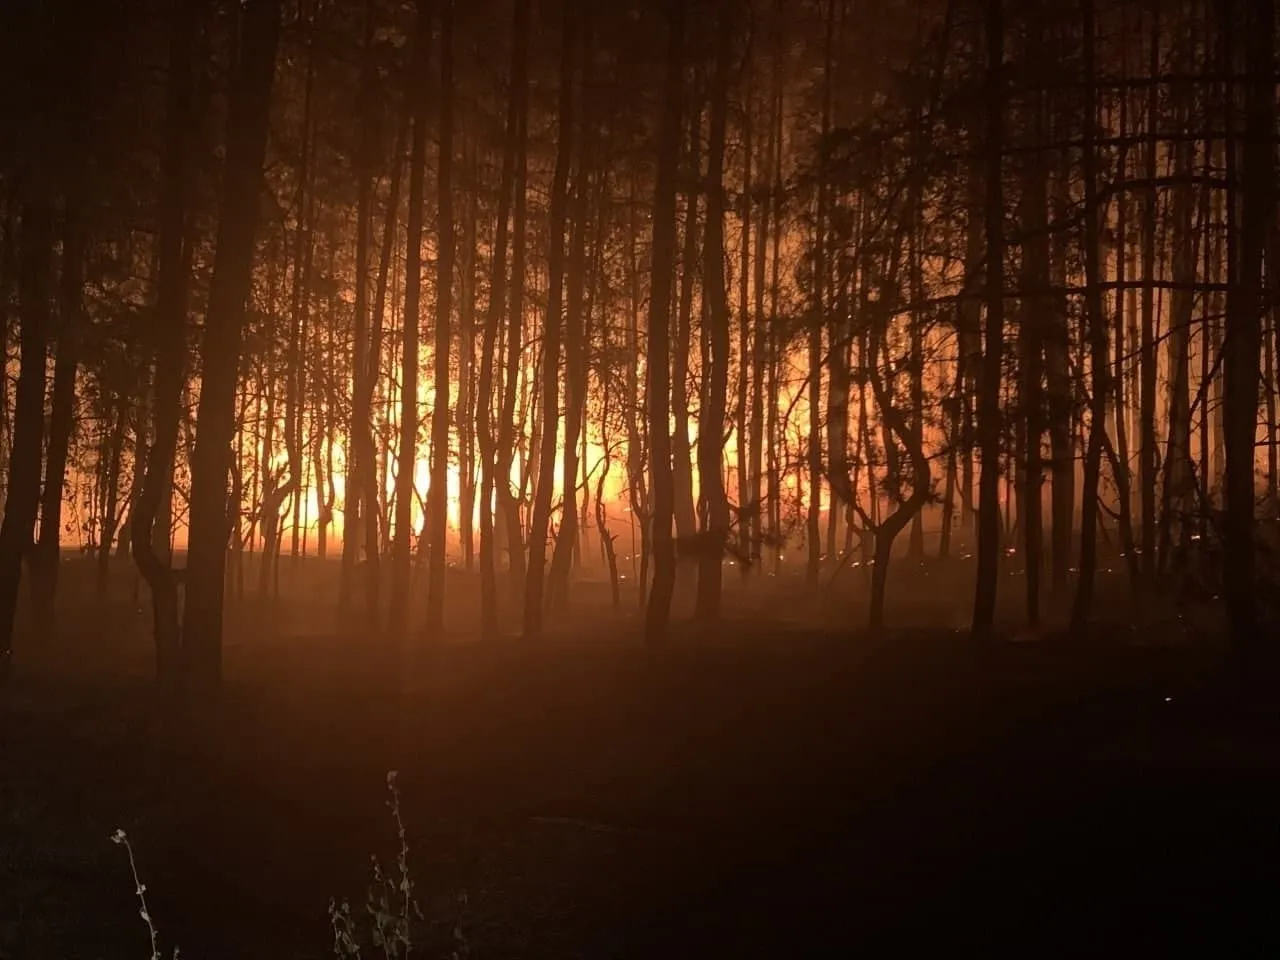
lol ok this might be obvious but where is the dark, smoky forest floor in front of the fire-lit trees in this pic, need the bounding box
[0,560,1280,960]
